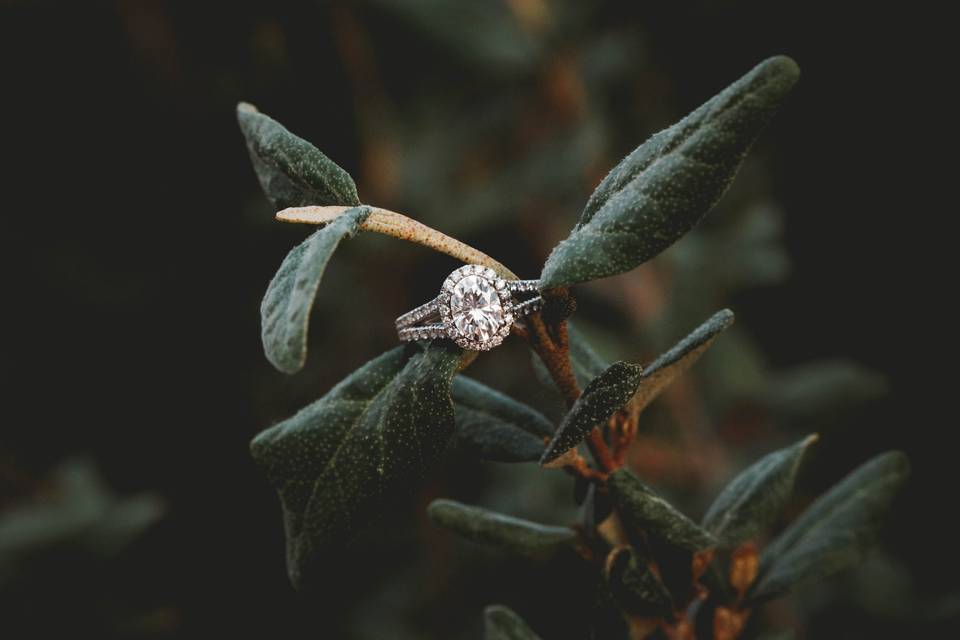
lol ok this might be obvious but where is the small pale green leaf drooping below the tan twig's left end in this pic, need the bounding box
[260,207,370,373]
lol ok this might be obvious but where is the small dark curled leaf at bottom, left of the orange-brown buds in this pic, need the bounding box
[604,547,674,618]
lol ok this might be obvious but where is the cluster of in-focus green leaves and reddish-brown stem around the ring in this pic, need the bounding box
[237,57,908,639]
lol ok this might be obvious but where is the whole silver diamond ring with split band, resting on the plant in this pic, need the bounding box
[396,264,543,351]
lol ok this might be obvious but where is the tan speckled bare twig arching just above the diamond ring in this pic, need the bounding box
[277,205,519,280]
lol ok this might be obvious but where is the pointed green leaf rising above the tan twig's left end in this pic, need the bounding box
[237,102,360,209]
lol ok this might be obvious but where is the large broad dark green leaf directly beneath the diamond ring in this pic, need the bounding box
[250,341,462,588]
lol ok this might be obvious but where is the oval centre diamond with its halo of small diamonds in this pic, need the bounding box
[437,265,514,351]
